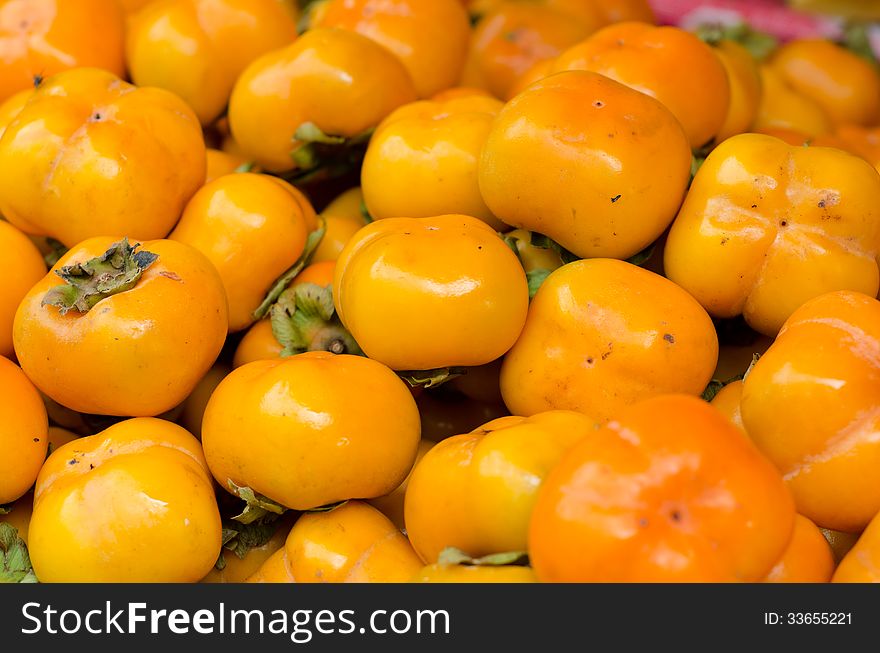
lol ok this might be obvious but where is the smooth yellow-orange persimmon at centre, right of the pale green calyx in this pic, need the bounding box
[333,215,529,370]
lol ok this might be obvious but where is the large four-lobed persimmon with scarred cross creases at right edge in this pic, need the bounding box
[664,134,880,337]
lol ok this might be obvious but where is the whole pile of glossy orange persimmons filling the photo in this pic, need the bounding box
[0,0,880,583]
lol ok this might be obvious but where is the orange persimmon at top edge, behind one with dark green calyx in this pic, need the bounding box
[310,0,470,98]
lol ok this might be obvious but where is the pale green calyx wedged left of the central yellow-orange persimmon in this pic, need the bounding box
[269,283,363,357]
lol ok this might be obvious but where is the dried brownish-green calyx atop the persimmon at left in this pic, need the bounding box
[42,238,159,315]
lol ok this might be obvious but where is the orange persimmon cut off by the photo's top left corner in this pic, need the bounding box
[0,0,125,102]
